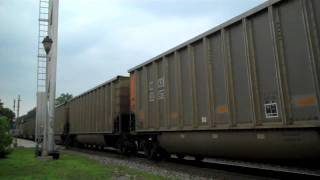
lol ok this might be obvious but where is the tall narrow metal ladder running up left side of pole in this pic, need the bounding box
[35,0,50,145]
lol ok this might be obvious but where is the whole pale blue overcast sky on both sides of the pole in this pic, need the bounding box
[0,0,266,114]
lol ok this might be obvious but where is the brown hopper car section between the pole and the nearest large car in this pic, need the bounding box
[54,76,130,150]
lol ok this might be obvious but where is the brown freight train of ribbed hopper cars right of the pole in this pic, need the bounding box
[21,0,320,160]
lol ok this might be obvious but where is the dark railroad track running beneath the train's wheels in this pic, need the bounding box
[62,148,320,179]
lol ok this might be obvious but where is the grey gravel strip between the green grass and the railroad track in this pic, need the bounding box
[63,149,266,180]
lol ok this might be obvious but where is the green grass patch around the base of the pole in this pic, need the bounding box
[0,148,164,180]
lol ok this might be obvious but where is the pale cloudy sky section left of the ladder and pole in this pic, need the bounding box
[0,0,38,113]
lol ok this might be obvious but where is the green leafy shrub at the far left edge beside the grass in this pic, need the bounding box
[0,116,12,158]
